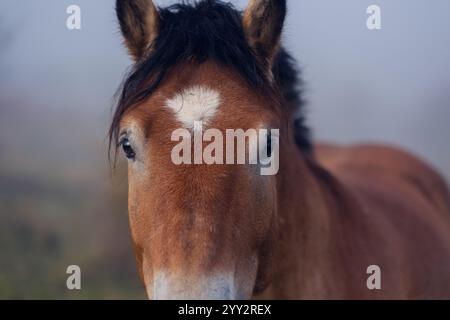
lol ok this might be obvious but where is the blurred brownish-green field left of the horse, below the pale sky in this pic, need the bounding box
[0,100,145,299]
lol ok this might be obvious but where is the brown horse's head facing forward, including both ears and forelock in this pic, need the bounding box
[112,0,285,299]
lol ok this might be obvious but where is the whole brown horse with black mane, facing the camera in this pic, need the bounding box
[110,0,450,299]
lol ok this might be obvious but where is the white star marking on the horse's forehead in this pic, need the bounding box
[166,86,221,129]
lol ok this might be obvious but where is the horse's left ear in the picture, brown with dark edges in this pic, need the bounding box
[116,0,160,61]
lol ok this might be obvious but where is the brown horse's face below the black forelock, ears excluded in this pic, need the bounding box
[120,63,279,299]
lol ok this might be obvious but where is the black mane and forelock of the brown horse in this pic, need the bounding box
[109,0,312,152]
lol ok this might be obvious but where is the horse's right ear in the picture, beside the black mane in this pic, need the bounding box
[243,0,286,67]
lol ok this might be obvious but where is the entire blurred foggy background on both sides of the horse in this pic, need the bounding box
[0,0,450,299]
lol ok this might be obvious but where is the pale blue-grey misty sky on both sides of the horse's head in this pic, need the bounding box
[0,0,450,177]
